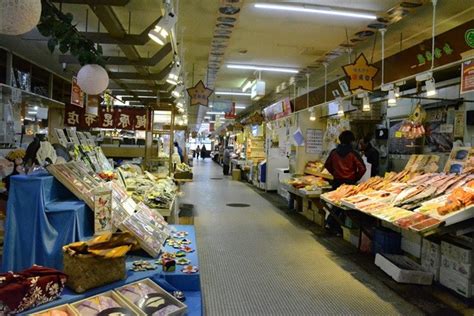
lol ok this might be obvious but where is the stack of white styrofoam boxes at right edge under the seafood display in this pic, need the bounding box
[439,241,473,298]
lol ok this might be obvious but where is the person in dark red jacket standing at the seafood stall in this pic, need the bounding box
[324,131,366,234]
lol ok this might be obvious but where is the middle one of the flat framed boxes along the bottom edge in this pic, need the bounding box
[71,291,141,316]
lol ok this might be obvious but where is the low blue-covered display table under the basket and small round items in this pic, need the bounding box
[27,225,202,316]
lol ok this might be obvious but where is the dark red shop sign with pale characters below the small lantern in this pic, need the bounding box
[64,105,149,131]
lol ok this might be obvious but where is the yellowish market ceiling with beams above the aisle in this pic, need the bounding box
[0,0,474,130]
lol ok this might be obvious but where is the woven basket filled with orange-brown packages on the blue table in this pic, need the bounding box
[63,233,138,293]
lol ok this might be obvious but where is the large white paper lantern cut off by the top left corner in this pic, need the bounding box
[0,0,41,35]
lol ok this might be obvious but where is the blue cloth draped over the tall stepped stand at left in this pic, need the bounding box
[2,175,93,272]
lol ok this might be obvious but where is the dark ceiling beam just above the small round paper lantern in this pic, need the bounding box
[59,43,173,67]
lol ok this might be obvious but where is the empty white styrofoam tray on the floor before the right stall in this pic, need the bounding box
[375,253,433,285]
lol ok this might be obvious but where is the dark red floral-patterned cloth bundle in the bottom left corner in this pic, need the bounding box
[0,266,67,315]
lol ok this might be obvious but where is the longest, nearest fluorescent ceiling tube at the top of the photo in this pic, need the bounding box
[255,3,377,20]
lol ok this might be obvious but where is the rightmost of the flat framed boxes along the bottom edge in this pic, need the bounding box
[115,279,187,316]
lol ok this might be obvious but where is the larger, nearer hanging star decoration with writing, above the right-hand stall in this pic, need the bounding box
[342,54,379,92]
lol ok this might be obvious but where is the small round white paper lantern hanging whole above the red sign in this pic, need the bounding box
[77,64,109,95]
